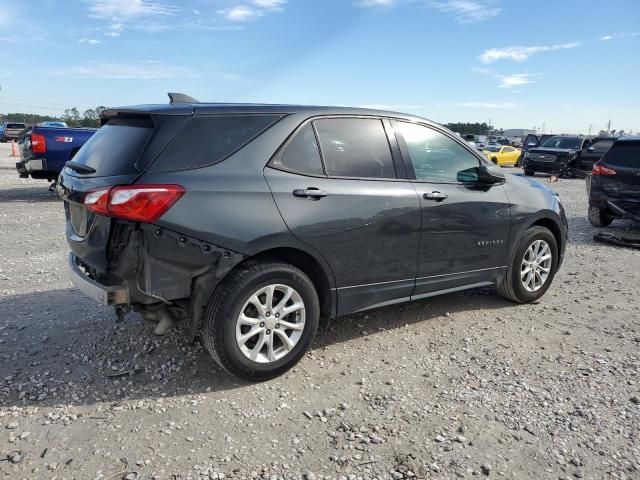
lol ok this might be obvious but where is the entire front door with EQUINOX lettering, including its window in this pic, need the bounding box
[394,121,510,297]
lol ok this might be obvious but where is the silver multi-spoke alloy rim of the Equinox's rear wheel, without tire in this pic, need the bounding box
[236,284,305,363]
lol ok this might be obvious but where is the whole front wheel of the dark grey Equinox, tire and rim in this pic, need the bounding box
[498,226,559,303]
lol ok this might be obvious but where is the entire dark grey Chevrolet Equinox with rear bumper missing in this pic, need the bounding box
[57,97,567,379]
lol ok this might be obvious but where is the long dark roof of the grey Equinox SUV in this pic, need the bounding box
[102,103,435,123]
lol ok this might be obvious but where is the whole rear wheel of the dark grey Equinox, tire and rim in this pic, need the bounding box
[203,263,320,380]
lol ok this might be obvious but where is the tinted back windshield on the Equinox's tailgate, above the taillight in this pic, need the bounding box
[73,118,153,177]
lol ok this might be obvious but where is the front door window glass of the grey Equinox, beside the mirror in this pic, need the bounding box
[395,122,480,183]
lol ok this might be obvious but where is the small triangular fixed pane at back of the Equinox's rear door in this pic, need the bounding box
[271,123,324,175]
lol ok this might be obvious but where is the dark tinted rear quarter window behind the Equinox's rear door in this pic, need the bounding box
[152,115,281,171]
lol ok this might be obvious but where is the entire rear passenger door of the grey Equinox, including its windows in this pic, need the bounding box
[265,117,421,315]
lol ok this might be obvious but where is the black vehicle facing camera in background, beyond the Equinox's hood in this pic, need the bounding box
[522,136,589,176]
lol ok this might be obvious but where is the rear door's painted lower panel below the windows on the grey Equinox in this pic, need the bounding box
[265,168,421,315]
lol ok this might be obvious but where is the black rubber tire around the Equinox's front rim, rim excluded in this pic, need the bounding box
[497,226,559,303]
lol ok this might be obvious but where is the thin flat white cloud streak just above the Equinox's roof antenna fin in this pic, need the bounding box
[49,61,195,80]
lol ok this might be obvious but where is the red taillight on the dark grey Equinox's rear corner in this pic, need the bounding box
[84,185,185,223]
